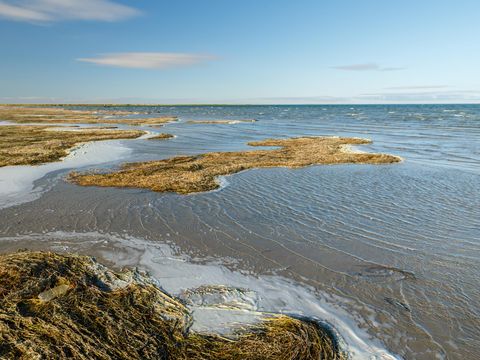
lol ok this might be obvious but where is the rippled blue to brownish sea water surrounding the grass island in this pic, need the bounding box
[0,105,480,360]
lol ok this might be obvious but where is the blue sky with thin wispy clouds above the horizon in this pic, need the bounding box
[0,0,480,104]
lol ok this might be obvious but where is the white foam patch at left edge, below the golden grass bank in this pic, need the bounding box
[0,140,131,209]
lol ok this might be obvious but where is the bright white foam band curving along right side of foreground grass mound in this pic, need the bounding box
[130,239,395,359]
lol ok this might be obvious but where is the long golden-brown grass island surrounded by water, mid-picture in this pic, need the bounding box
[70,137,400,194]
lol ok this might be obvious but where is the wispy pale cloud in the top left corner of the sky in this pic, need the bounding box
[0,0,140,23]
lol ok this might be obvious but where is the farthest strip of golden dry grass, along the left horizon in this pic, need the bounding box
[0,105,177,126]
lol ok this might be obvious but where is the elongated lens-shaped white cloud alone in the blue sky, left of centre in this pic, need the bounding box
[77,52,215,69]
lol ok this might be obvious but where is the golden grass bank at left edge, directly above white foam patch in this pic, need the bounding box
[0,125,144,167]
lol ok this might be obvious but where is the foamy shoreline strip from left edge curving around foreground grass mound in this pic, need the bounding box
[2,232,397,360]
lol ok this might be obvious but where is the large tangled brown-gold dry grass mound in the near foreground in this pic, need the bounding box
[0,252,344,360]
